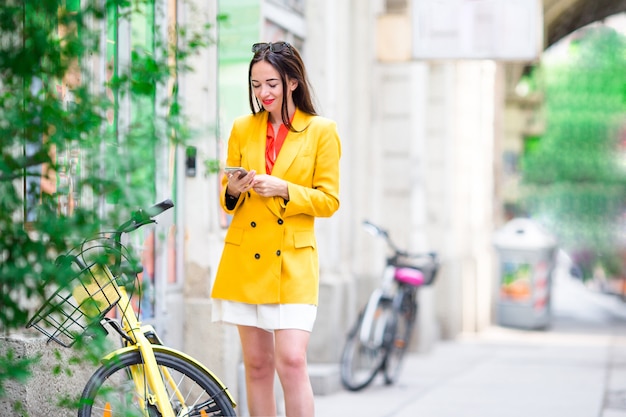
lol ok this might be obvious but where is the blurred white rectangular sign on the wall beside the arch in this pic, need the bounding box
[412,0,543,61]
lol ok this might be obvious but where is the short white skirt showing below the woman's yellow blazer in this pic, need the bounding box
[211,298,317,332]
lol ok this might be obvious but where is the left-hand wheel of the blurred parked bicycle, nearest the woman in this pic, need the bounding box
[341,295,392,391]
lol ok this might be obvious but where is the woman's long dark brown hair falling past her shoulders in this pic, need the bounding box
[248,42,317,131]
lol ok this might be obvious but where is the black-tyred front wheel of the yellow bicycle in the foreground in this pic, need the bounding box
[78,350,236,417]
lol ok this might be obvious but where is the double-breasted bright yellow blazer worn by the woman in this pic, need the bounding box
[212,110,341,305]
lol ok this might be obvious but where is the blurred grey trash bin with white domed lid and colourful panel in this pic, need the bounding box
[493,218,557,329]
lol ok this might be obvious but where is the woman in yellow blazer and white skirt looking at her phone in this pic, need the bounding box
[212,42,341,417]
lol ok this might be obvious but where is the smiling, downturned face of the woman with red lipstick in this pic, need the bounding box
[250,61,298,118]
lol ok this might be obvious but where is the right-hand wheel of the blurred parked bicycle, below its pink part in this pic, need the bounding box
[383,286,417,385]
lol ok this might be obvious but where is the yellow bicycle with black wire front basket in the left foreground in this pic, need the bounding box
[27,200,236,417]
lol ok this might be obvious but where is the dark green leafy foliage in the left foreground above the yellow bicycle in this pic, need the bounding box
[0,0,211,410]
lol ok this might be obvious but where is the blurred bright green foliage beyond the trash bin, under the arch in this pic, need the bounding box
[522,26,626,276]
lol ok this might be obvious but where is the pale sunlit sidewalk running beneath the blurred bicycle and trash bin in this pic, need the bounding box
[315,268,626,417]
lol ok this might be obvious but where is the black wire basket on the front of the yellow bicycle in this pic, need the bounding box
[26,237,121,347]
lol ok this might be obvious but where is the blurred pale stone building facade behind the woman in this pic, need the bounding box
[183,0,626,398]
